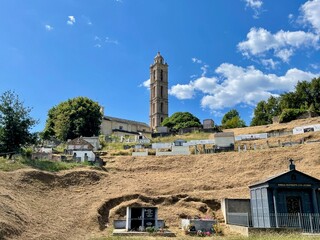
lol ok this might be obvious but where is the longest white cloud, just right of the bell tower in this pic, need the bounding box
[169,63,320,111]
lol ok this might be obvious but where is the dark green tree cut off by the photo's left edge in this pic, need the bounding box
[0,91,37,158]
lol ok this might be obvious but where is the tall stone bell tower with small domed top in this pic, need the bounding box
[150,52,168,131]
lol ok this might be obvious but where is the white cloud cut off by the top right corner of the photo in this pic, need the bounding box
[300,0,320,33]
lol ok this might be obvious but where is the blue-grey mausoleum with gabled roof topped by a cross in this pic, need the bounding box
[249,160,320,228]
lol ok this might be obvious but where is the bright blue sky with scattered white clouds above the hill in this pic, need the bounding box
[0,0,320,131]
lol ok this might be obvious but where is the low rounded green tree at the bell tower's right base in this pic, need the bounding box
[161,112,201,131]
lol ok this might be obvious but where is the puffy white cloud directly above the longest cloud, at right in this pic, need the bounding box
[238,28,320,62]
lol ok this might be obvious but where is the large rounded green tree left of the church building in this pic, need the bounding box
[42,97,103,141]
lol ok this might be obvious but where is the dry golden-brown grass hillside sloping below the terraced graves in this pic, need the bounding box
[0,118,320,240]
